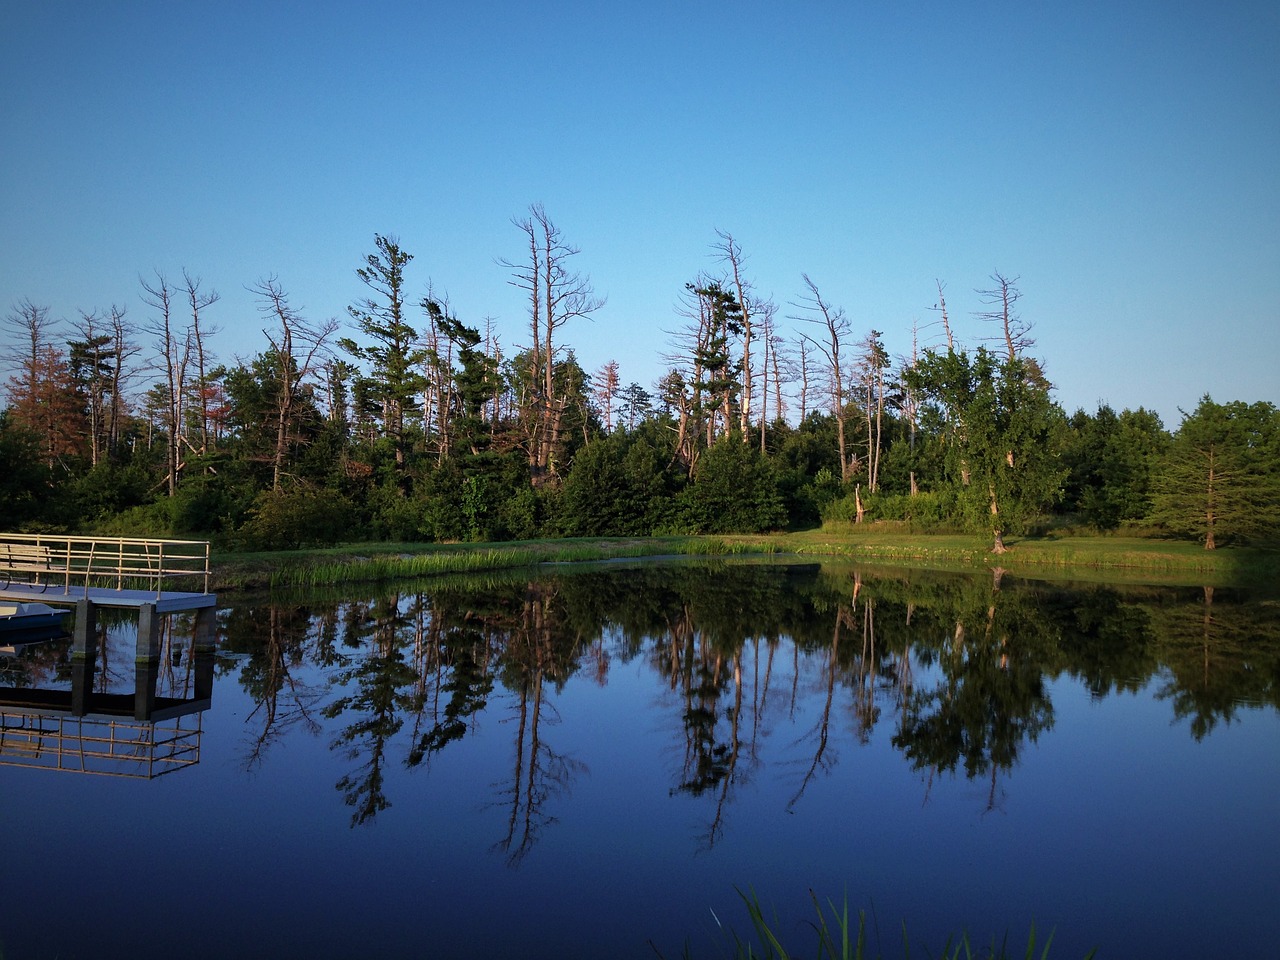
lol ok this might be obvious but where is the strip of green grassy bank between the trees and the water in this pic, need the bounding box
[214,525,1280,591]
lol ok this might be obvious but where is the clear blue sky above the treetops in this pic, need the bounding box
[0,0,1280,426]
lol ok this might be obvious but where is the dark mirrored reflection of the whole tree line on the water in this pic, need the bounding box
[223,562,1280,865]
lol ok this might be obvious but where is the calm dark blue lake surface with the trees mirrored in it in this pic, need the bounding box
[0,562,1280,960]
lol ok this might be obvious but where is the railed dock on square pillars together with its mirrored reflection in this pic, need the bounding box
[0,534,218,778]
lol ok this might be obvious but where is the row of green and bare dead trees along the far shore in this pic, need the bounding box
[0,205,1280,552]
